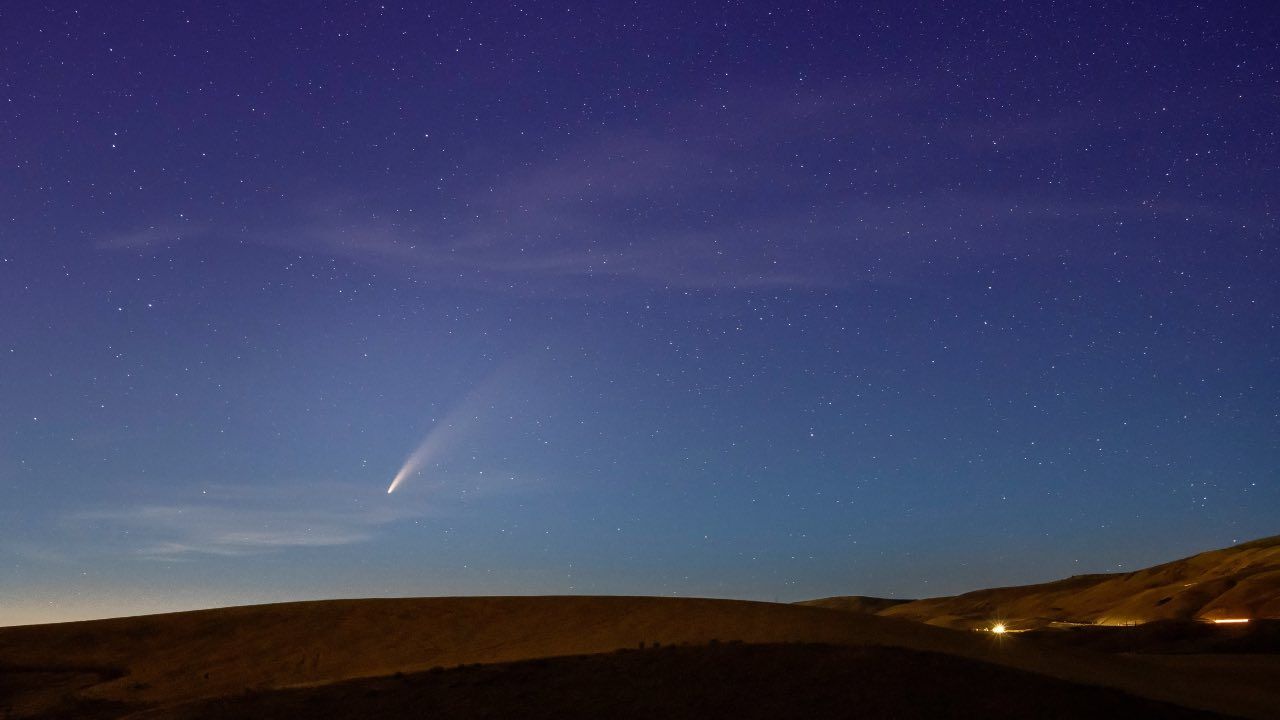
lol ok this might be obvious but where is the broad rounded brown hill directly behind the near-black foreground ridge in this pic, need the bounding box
[0,597,1280,717]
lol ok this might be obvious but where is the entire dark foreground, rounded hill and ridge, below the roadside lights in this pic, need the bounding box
[0,597,1280,720]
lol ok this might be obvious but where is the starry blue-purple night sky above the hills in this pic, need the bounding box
[0,0,1280,624]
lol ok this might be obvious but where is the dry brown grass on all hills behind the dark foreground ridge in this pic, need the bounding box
[0,538,1280,719]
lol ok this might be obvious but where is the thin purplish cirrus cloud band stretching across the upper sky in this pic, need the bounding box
[99,82,1259,295]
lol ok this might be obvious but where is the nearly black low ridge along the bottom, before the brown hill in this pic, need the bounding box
[138,643,1222,720]
